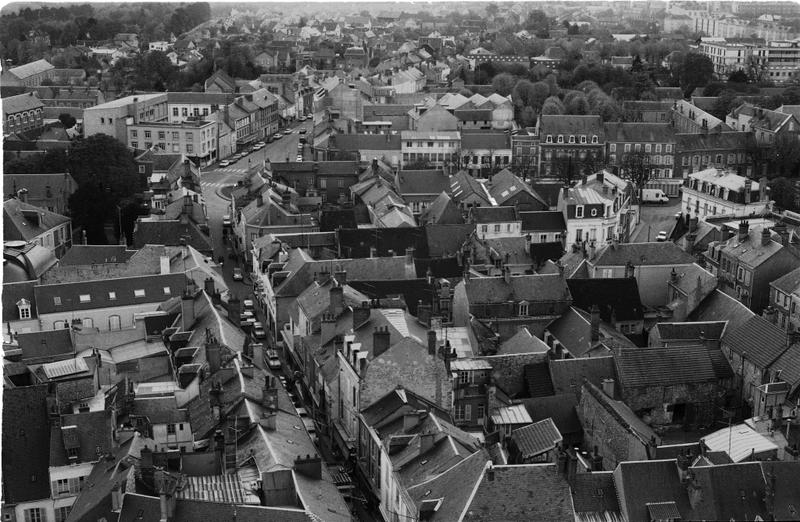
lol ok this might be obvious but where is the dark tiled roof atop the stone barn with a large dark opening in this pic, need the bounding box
[615,345,733,388]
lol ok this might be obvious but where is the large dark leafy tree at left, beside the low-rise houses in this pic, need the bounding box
[67,134,143,244]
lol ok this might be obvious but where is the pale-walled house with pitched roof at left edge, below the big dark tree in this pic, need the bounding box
[3,197,72,258]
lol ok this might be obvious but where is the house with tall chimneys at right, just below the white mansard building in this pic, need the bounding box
[704,220,798,313]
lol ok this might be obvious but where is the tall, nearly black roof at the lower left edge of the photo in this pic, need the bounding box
[2,384,50,504]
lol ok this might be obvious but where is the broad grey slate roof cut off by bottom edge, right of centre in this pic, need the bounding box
[463,464,575,521]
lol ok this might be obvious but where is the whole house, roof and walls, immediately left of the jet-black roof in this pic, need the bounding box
[453,270,572,341]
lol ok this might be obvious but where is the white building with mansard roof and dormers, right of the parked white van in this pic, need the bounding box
[681,168,770,220]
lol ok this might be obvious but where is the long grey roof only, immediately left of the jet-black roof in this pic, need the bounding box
[465,274,571,305]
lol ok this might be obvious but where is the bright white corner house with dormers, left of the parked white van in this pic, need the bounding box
[557,171,636,248]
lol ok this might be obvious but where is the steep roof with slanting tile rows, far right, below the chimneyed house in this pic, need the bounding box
[722,315,788,370]
